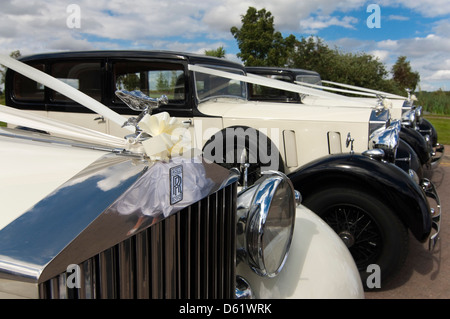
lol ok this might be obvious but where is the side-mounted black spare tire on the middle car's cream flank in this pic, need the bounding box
[203,131,284,186]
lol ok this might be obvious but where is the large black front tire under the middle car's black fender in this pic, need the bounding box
[303,187,409,289]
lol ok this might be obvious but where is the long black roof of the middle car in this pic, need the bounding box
[20,50,244,70]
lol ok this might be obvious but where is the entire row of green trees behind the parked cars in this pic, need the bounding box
[231,7,420,95]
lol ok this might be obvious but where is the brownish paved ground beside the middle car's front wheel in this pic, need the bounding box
[366,145,450,299]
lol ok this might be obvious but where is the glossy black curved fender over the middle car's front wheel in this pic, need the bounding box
[288,154,431,242]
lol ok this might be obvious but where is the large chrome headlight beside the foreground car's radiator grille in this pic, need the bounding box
[237,172,296,277]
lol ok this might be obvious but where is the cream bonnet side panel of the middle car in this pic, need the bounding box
[199,99,371,172]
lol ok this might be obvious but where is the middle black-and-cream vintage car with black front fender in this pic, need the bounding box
[1,51,440,283]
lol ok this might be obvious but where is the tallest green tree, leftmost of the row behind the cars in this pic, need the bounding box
[230,7,295,66]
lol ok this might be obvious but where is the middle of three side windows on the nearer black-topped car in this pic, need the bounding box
[51,61,102,102]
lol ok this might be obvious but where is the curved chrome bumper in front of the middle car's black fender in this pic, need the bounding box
[420,178,442,251]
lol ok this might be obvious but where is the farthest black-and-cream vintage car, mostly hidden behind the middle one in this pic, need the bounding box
[246,67,444,171]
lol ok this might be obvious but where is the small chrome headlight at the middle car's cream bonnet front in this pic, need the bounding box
[369,121,401,163]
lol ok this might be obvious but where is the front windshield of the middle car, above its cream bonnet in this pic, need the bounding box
[195,66,247,101]
